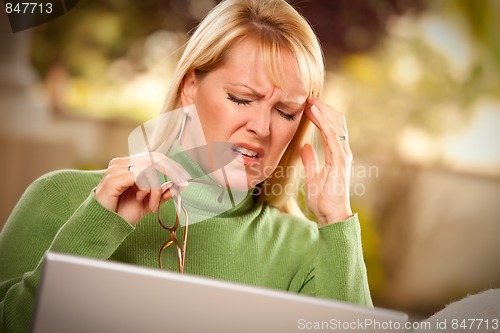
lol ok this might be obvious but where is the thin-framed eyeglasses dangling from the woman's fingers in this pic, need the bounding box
[157,179,224,274]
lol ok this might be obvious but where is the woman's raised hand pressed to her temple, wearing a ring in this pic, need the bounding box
[301,98,352,225]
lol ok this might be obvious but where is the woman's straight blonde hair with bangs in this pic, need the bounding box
[157,0,324,214]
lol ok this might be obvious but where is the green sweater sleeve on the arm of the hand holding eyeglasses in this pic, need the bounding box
[0,175,133,333]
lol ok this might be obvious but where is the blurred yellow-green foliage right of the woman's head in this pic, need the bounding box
[325,0,500,164]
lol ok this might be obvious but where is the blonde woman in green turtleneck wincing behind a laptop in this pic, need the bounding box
[0,0,371,332]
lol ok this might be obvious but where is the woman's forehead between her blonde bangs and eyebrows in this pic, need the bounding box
[219,39,307,95]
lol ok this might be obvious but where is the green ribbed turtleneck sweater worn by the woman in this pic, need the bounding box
[0,159,372,332]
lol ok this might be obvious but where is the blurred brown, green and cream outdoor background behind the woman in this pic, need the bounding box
[0,0,500,317]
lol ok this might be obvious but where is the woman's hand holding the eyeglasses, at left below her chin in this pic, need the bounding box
[95,152,191,226]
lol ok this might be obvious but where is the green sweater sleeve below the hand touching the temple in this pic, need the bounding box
[300,215,373,306]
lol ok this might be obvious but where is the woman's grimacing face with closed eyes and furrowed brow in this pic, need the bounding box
[181,40,307,188]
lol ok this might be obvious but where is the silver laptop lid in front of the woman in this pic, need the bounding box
[32,252,407,333]
